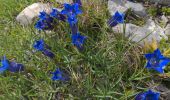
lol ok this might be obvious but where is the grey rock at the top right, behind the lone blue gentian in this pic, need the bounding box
[108,0,147,17]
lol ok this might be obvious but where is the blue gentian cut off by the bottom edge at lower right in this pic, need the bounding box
[135,90,160,100]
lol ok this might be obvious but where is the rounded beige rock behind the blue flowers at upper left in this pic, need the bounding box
[16,3,51,25]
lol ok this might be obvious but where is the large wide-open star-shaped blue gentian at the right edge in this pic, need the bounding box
[145,49,170,73]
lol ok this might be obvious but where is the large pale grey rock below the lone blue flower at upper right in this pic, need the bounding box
[113,19,168,46]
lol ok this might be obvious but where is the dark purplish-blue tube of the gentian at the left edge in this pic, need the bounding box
[9,62,24,72]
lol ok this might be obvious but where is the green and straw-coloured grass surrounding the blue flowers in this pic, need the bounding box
[0,0,169,100]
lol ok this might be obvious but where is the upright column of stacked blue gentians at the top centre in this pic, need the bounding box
[61,0,86,50]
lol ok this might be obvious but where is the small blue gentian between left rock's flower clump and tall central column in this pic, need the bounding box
[50,8,66,21]
